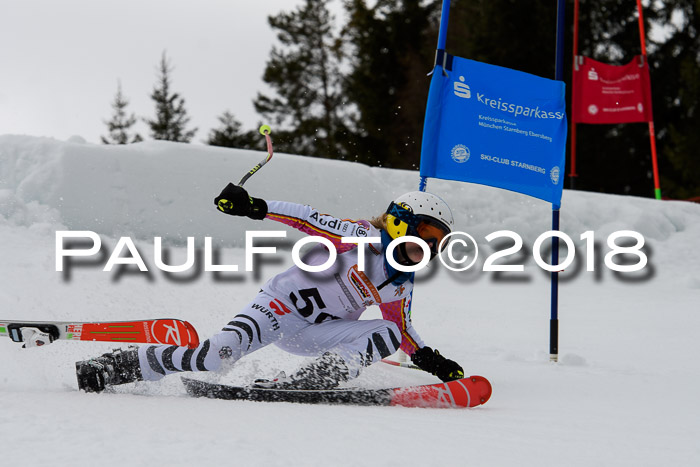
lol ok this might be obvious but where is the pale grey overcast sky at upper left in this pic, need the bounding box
[0,0,334,143]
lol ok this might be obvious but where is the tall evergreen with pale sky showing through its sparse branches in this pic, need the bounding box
[254,0,348,158]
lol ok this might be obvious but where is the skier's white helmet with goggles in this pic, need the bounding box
[386,191,454,255]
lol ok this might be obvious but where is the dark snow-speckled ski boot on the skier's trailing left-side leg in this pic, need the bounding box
[75,346,143,392]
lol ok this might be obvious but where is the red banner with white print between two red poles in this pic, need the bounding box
[571,55,653,124]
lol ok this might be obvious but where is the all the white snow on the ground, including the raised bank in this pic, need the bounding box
[0,135,700,466]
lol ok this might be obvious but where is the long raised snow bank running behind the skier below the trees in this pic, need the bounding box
[0,136,700,246]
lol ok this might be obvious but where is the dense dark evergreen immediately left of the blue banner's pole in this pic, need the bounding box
[344,0,440,168]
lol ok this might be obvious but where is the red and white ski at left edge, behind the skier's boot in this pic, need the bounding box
[0,319,199,348]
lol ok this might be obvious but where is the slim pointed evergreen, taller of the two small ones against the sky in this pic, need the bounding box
[146,52,197,143]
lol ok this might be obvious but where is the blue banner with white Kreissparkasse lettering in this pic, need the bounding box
[420,57,567,206]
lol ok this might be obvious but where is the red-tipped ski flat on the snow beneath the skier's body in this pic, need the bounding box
[182,376,491,408]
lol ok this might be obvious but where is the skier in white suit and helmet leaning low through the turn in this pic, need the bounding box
[76,183,464,392]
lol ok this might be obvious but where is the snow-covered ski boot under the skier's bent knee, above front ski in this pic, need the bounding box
[253,352,350,389]
